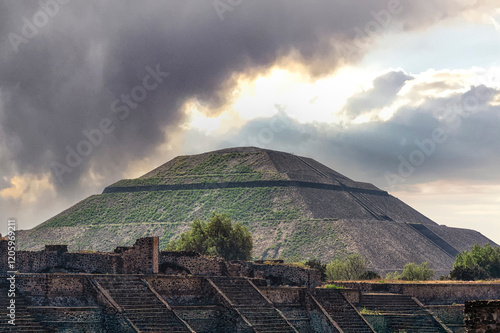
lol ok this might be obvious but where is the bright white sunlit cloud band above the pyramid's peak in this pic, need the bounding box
[183,66,500,134]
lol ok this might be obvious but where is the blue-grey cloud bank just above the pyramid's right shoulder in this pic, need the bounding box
[210,86,500,189]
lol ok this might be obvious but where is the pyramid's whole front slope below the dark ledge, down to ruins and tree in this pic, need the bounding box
[21,182,345,259]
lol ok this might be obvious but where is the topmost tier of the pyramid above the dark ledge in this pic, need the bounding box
[106,147,378,190]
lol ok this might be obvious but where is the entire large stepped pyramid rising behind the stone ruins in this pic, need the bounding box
[20,147,493,274]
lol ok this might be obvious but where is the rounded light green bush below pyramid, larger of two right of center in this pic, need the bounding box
[325,254,368,280]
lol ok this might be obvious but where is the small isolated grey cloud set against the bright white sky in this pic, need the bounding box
[345,71,414,118]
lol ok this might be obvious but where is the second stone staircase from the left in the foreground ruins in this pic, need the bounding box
[94,275,191,333]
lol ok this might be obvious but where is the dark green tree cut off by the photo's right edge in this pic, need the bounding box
[450,244,500,280]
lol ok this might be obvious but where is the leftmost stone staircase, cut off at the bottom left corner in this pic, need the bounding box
[0,281,50,333]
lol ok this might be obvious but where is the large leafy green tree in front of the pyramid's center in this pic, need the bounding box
[166,213,253,260]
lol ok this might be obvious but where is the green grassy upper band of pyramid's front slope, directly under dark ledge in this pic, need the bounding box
[44,187,303,228]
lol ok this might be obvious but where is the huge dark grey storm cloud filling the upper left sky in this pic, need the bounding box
[0,0,490,188]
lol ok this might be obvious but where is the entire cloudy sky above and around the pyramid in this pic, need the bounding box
[0,0,500,243]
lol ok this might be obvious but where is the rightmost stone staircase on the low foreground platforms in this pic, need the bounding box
[359,294,446,333]
